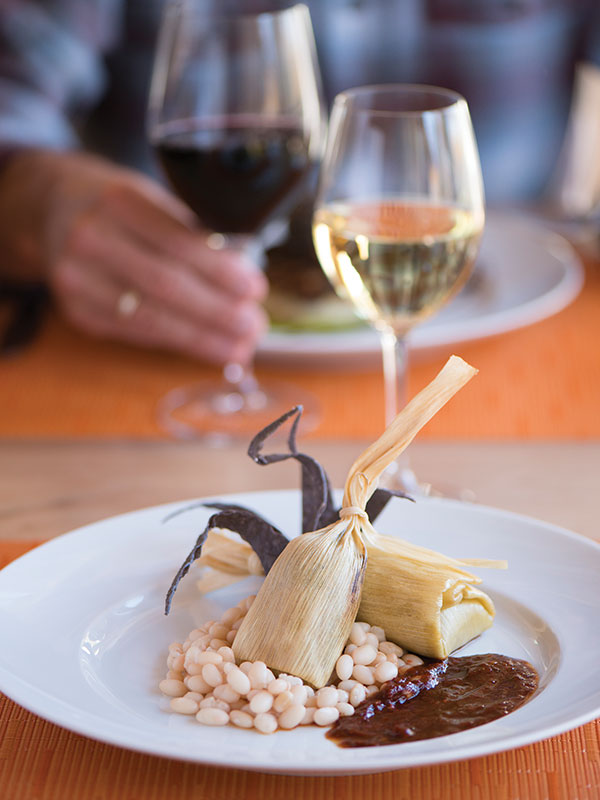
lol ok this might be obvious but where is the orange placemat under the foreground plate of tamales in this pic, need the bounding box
[0,541,600,800]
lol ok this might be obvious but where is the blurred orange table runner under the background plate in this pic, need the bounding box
[0,250,600,439]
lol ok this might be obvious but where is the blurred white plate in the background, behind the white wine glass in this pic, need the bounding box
[259,212,584,366]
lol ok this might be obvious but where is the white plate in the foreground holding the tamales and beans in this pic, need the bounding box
[0,491,600,775]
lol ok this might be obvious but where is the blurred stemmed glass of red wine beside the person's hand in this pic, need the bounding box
[148,0,325,440]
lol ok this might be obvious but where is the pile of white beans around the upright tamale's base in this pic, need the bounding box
[159,596,423,733]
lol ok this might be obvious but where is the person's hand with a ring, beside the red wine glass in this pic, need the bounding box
[0,151,266,364]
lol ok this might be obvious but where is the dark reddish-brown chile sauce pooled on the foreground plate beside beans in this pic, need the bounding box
[327,654,538,747]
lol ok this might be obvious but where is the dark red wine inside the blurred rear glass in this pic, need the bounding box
[155,122,312,233]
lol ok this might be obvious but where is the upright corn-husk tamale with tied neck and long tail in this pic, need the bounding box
[233,356,477,687]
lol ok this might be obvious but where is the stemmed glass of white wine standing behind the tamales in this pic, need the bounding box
[313,85,484,492]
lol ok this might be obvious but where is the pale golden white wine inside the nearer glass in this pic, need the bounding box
[313,199,483,334]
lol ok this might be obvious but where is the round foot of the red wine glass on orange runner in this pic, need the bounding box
[157,379,319,447]
